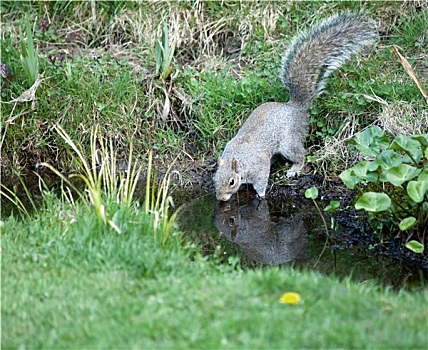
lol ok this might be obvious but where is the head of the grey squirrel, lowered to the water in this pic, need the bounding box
[214,157,241,202]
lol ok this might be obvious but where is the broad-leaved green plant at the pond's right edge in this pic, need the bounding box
[340,126,428,252]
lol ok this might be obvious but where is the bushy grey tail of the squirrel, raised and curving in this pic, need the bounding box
[280,13,378,107]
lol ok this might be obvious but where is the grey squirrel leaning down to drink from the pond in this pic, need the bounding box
[214,12,378,201]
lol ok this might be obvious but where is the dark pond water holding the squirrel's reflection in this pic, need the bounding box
[179,189,428,288]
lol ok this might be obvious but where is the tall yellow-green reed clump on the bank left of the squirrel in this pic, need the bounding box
[33,125,177,246]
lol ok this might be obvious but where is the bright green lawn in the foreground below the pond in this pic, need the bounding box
[2,196,428,349]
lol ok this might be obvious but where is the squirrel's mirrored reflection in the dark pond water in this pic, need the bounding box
[214,199,306,265]
